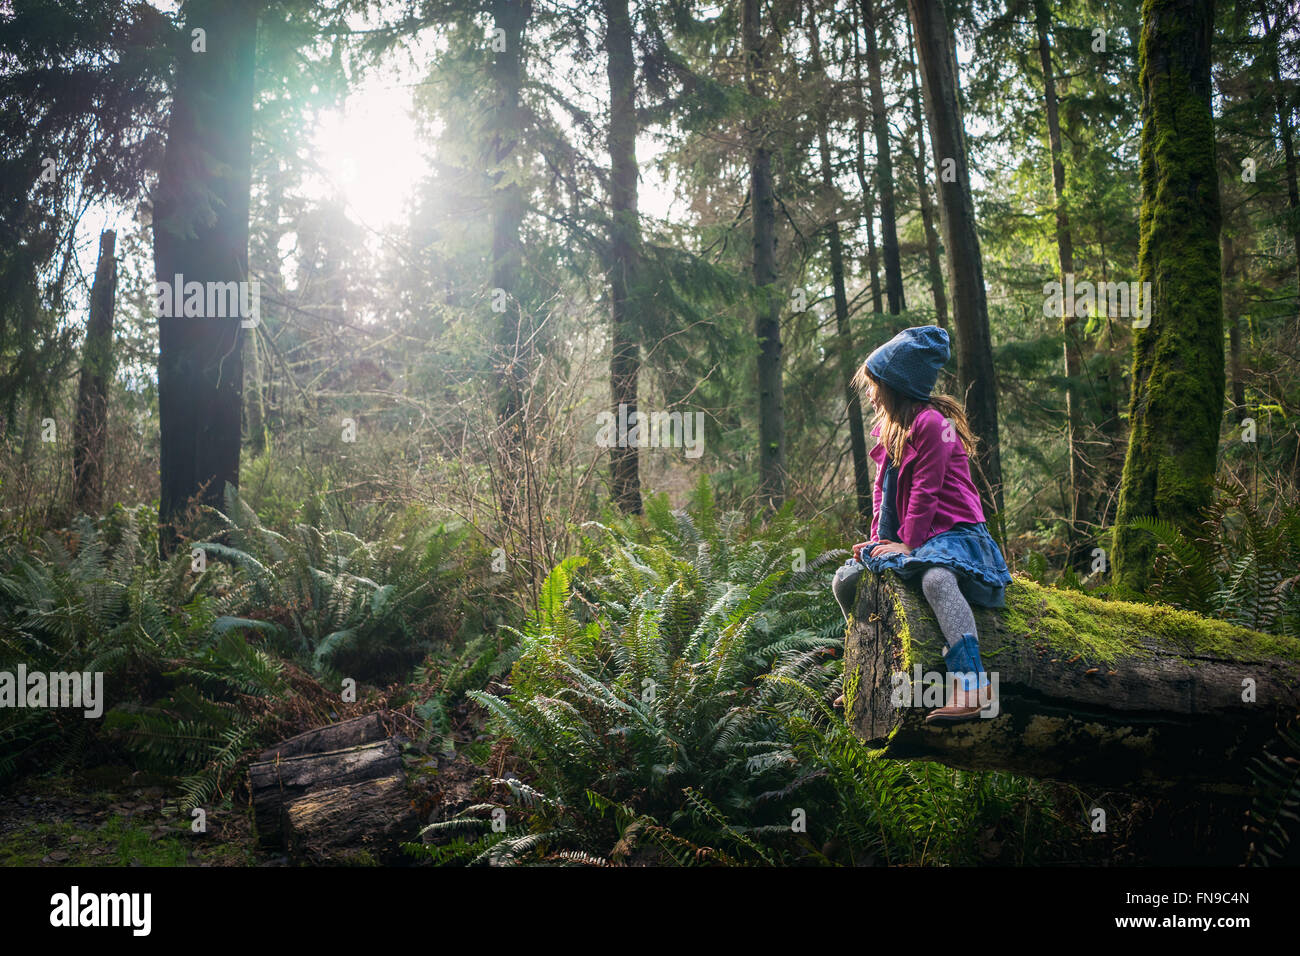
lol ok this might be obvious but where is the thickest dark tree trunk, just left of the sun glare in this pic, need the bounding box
[153,0,260,553]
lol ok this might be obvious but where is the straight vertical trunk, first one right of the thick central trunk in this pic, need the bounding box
[741,0,785,510]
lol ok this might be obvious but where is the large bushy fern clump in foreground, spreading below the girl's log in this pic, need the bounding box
[410,481,1076,865]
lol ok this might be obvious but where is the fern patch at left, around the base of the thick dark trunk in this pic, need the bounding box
[0,490,481,809]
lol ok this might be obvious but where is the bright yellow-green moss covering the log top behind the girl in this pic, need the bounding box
[992,576,1300,663]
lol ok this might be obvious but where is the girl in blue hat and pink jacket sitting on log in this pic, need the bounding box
[832,325,1011,723]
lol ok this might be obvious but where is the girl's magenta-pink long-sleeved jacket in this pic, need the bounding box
[871,408,984,550]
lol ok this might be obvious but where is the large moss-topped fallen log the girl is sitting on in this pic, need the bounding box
[844,572,1300,795]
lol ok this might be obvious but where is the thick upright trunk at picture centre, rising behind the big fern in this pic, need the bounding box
[605,0,645,514]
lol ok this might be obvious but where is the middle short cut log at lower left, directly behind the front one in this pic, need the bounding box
[248,740,403,845]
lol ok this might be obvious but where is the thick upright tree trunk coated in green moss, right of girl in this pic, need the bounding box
[1113,0,1225,591]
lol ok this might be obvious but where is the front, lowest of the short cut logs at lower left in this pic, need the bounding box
[285,774,419,864]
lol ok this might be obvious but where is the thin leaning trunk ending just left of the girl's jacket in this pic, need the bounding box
[809,17,874,533]
